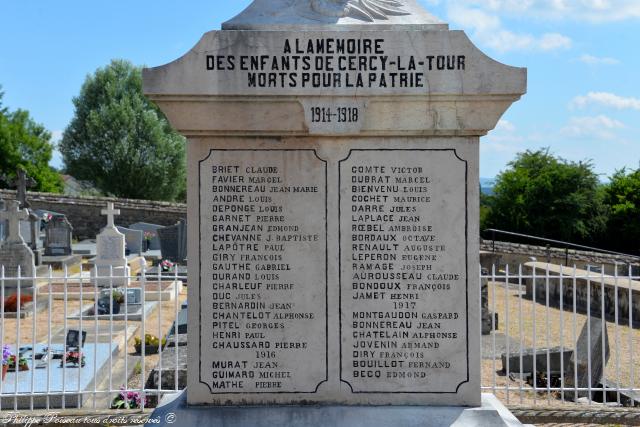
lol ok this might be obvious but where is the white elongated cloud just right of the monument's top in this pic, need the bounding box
[448,4,572,52]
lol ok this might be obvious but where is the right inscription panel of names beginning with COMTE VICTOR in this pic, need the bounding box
[340,149,469,394]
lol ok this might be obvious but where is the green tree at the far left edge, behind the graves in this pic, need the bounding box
[0,87,62,193]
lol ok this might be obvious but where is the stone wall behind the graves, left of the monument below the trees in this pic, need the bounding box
[0,190,187,240]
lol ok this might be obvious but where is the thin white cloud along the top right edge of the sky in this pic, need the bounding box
[447,0,640,23]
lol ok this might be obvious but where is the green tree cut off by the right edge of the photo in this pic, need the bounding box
[604,169,640,253]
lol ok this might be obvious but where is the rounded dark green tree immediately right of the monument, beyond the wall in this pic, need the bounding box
[484,149,606,244]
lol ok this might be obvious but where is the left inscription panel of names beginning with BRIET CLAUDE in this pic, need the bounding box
[198,149,327,395]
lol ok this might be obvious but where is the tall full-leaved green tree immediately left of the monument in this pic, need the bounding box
[60,60,186,204]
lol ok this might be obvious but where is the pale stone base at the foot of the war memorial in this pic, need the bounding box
[149,390,523,427]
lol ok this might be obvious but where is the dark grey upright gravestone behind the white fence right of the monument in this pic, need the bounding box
[565,316,610,397]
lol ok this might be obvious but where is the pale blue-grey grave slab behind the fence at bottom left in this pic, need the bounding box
[0,343,119,409]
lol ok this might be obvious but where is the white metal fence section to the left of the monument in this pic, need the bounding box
[0,267,186,411]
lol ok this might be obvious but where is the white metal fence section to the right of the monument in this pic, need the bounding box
[481,262,640,406]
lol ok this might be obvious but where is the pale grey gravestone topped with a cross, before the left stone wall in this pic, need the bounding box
[91,202,131,287]
